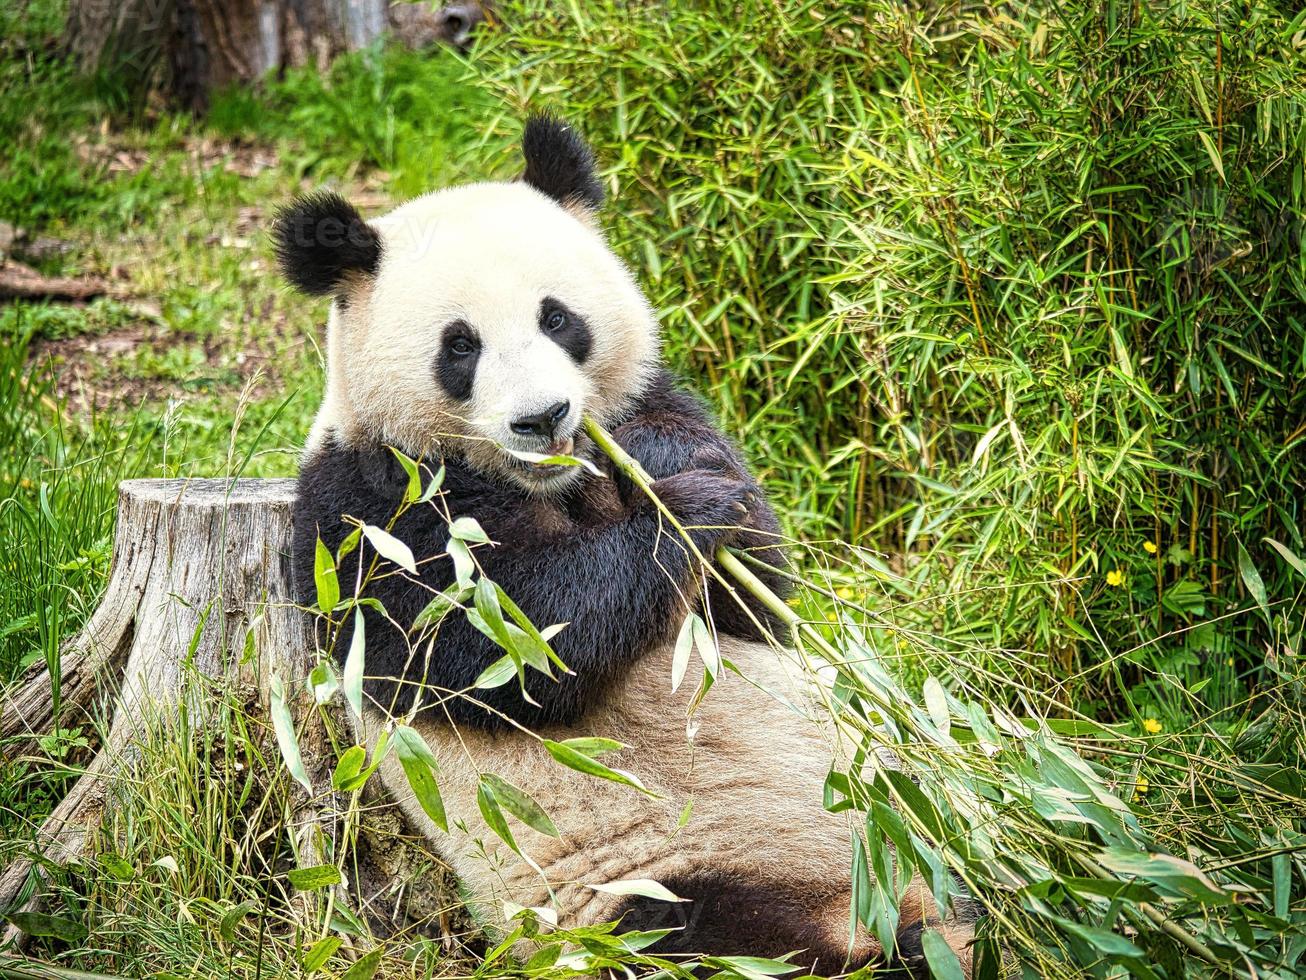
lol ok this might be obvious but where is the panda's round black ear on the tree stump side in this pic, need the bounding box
[272,191,381,297]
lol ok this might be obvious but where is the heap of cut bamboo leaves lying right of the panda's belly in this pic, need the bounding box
[814,582,1306,980]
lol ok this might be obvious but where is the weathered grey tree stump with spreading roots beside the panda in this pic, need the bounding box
[0,480,323,946]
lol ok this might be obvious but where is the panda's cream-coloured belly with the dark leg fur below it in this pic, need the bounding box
[372,638,876,972]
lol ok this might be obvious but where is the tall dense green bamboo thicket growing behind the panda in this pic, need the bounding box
[479,0,1306,712]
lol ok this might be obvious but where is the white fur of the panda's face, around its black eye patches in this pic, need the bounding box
[308,183,658,488]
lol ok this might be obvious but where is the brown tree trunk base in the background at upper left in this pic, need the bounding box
[65,0,488,111]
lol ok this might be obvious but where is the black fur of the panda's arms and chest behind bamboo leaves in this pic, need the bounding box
[294,375,785,728]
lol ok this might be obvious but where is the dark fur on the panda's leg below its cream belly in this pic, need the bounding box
[614,872,879,976]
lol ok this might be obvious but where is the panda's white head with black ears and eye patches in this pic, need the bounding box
[273,116,658,493]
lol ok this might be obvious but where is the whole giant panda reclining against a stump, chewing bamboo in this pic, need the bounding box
[274,116,970,975]
